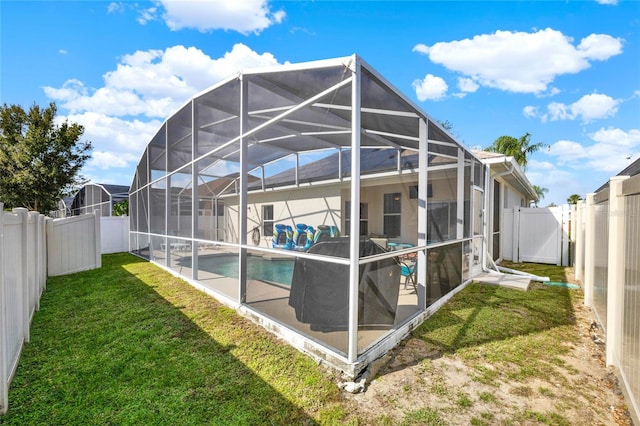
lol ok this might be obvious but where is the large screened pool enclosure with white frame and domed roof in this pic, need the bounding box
[130,55,486,376]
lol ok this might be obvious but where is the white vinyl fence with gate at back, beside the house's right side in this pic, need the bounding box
[502,205,571,266]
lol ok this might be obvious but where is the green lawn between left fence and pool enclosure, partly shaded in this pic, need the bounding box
[0,254,341,425]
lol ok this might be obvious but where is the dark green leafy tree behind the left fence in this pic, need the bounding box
[0,103,92,213]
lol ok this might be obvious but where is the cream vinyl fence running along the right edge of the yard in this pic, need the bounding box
[575,175,640,424]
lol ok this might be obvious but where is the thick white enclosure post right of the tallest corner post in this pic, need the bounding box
[417,117,429,311]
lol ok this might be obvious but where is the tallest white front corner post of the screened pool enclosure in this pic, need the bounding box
[347,55,362,363]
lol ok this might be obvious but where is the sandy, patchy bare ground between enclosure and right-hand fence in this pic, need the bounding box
[344,265,632,425]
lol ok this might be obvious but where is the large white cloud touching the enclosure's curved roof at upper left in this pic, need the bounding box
[44,44,278,118]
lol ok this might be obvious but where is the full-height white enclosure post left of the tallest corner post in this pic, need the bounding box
[238,74,249,303]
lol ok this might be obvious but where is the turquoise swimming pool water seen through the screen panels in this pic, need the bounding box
[198,254,295,286]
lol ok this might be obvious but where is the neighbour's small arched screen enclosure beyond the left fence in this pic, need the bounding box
[68,183,129,216]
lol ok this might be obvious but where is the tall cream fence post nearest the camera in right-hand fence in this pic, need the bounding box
[606,176,629,367]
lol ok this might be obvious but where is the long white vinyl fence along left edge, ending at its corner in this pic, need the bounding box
[0,208,104,415]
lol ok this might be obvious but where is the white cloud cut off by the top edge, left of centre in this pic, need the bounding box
[152,0,286,34]
